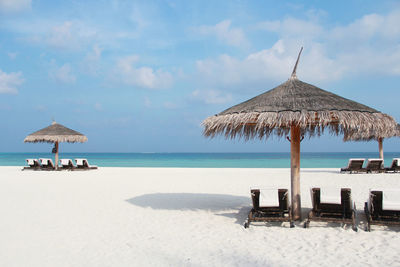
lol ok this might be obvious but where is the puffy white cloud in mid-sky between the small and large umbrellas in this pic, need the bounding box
[115,55,173,89]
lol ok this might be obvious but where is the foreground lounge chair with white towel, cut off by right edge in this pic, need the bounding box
[364,189,400,232]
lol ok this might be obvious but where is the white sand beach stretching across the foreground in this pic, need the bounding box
[0,167,400,267]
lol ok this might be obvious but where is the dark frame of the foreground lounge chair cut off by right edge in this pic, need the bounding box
[364,190,400,232]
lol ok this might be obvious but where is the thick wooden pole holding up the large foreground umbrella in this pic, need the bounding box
[290,125,301,220]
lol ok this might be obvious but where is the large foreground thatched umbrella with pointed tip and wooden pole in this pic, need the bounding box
[203,50,396,220]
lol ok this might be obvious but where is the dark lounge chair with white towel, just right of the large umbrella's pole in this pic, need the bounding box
[304,187,357,231]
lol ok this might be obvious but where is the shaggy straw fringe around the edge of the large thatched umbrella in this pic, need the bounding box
[203,110,397,140]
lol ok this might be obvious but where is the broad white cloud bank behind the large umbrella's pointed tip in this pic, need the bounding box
[196,10,400,89]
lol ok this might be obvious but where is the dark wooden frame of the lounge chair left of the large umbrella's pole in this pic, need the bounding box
[244,189,294,228]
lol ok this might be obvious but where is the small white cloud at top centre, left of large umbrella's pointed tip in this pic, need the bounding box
[194,20,248,47]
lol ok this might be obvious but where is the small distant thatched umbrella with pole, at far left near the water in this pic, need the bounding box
[24,121,87,169]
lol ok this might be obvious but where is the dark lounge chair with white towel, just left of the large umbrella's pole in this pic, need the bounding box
[244,188,294,228]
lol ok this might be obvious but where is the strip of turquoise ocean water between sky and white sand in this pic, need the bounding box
[0,152,400,168]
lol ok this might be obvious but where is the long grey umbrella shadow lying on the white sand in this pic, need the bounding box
[127,193,251,225]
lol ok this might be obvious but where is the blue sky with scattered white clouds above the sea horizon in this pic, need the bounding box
[0,0,400,152]
